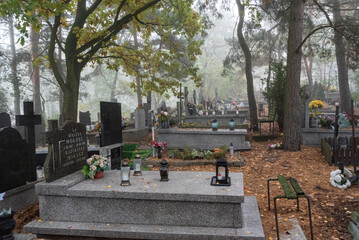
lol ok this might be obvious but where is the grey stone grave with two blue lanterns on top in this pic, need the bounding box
[157,128,251,150]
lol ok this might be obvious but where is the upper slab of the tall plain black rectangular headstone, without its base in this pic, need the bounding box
[100,102,122,147]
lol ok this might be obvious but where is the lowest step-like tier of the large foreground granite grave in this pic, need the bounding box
[25,197,265,240]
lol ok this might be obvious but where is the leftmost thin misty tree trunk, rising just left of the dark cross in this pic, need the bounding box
[9,16,20,115]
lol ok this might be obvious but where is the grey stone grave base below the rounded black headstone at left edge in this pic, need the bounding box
[0,180,43,212]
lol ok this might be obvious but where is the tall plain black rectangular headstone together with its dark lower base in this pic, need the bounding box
[100,102,122,169]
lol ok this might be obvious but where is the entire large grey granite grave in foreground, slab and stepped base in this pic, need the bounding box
[25,171,264,239]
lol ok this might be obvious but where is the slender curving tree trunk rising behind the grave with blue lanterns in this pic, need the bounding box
[236,0,258,130]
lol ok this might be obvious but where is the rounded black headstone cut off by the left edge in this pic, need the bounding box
[0,127,36,192]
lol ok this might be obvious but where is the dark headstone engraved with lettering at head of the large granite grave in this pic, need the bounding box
[44,120,87,182]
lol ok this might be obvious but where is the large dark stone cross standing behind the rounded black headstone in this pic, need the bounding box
[16,102,41,159]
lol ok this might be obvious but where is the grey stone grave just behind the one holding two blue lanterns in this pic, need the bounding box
[183,111,247,128]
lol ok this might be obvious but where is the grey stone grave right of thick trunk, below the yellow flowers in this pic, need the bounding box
[302,128,359,147]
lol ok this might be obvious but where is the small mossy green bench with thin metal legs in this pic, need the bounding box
[267,175,313,240]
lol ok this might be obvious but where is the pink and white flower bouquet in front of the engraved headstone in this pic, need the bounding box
[82,154,108,179]
